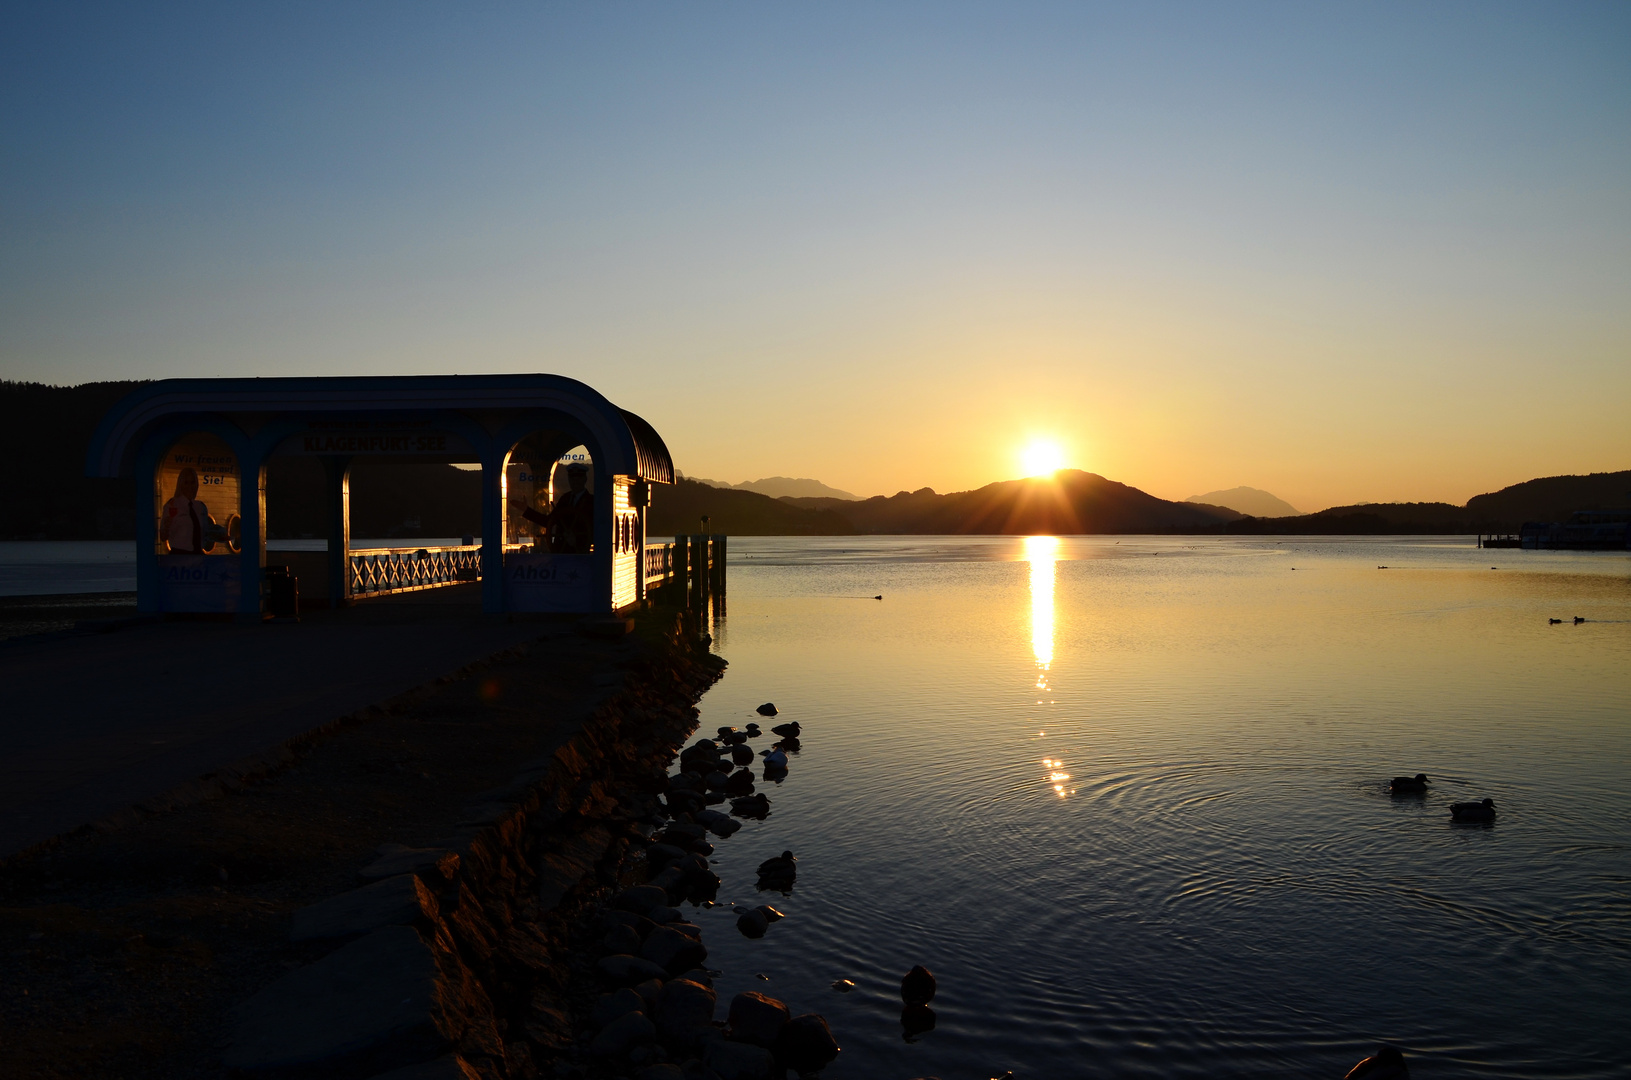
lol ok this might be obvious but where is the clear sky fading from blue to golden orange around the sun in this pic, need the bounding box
[0,2,1631,511]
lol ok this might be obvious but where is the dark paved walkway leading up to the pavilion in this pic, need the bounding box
[0,584,546,858]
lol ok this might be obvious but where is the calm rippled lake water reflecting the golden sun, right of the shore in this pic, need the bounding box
[698,537,1631,1080]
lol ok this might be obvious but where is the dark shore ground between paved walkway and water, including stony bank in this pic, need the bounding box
[0,609,723,1080]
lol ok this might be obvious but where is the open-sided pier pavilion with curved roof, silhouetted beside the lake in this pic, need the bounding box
[85,374,674,620]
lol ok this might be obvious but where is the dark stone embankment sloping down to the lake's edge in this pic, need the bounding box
[222,625,723,1080]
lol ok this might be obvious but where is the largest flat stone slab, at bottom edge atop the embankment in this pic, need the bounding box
[222,927,462,1072]
